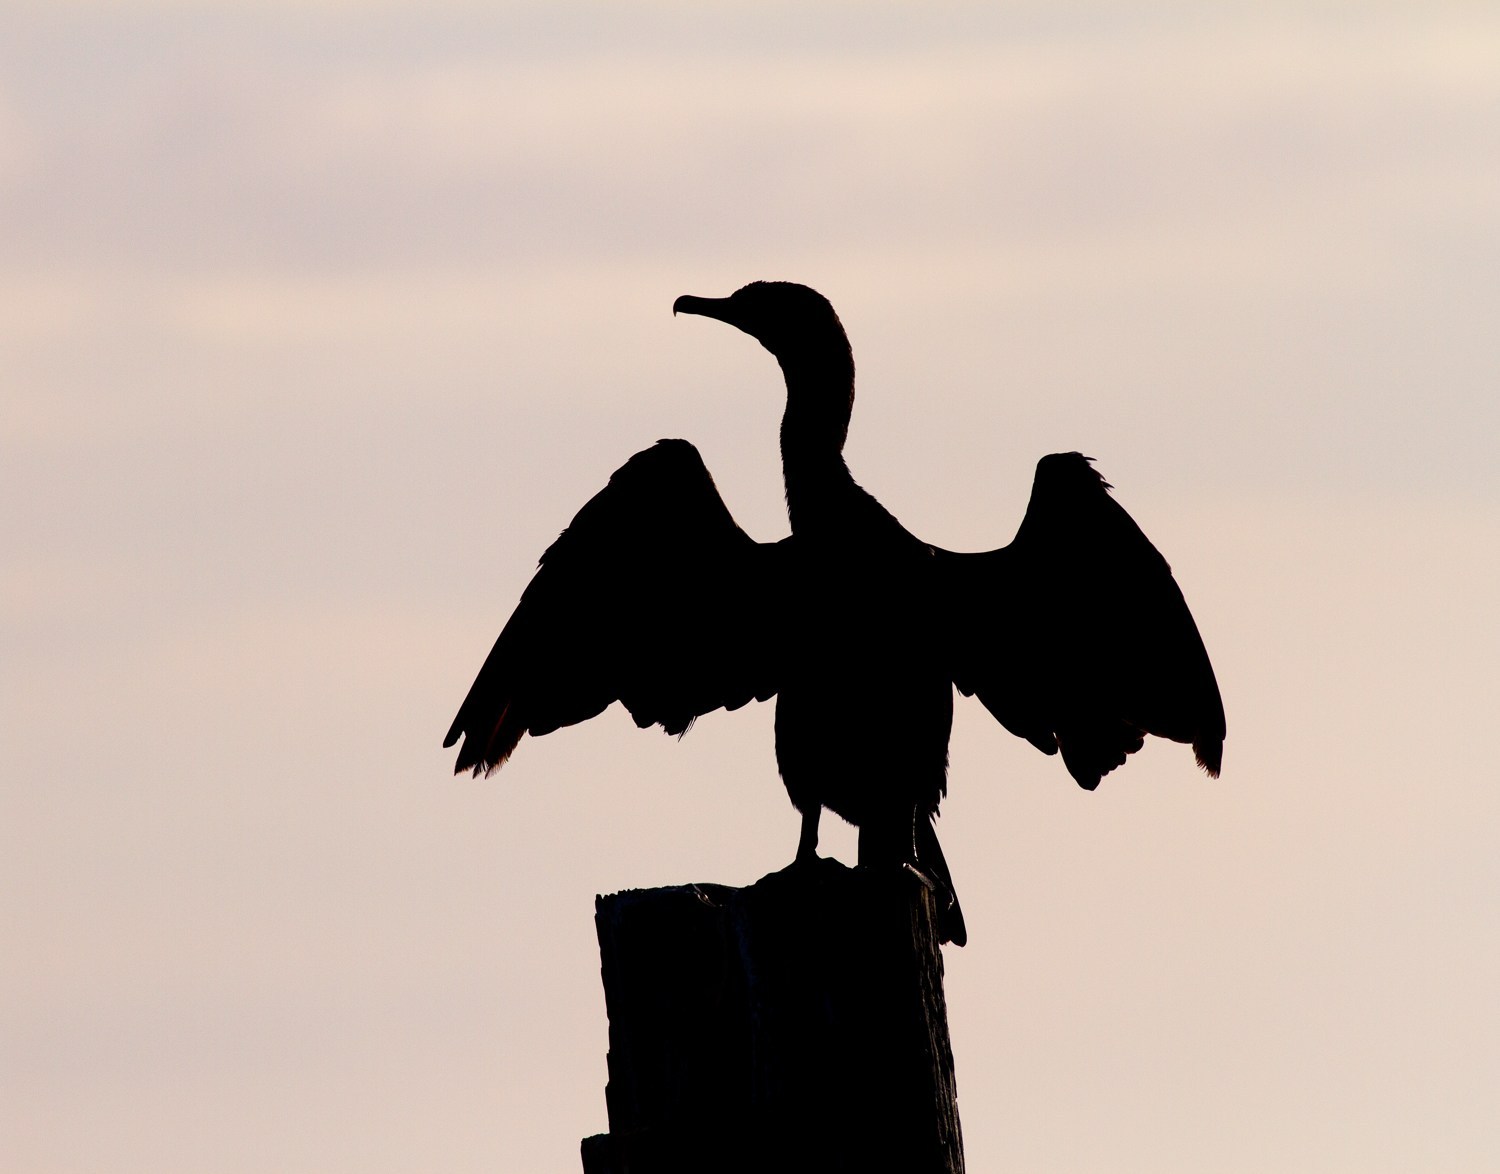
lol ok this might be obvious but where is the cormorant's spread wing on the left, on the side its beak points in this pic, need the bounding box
[443,441,786,775]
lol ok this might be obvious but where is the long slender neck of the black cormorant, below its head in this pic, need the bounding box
[779,339,854,532]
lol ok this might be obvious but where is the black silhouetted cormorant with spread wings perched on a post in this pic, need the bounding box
[444,282,1226,945]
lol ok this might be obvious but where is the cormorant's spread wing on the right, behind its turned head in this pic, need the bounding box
[936,453,1224,790]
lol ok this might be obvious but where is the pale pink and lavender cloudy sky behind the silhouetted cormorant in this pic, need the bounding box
[0,0,1500,1174]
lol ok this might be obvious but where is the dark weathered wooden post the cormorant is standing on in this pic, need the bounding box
[584,861,963,1174]
